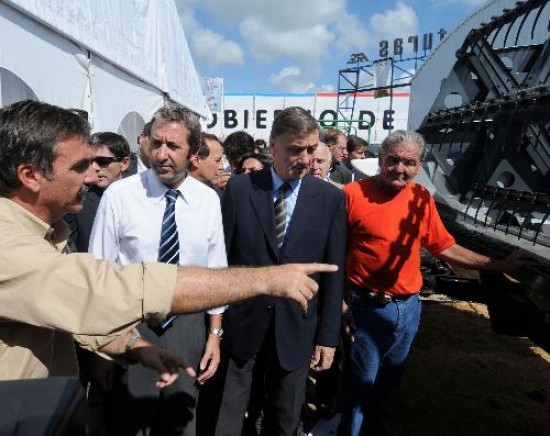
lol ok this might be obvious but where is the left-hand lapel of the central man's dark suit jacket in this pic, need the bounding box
[250,168,278,257]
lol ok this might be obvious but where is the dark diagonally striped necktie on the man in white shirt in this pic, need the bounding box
[157,189,180,334]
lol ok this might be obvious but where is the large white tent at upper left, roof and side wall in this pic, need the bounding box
[0,0,207,151]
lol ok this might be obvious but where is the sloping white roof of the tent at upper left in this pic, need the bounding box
[5,0,207,116]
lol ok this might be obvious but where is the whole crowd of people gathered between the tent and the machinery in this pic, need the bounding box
[0,101,530,436]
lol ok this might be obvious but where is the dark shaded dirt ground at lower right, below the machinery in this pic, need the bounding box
[388,299,550,436]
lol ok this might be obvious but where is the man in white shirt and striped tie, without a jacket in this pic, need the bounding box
[89,106,227,435]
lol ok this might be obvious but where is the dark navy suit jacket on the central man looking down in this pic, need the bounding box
[222,168,346,371]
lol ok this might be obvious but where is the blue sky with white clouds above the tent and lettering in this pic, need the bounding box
[175,0,486,93]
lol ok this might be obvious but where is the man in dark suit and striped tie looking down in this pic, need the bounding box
[216,107,346,436]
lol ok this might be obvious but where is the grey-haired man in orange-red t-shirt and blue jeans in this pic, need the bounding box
[340,130,529,436]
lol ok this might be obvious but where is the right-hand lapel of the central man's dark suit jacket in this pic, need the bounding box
[284,174,322,254]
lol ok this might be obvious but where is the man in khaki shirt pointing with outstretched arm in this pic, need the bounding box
[0,100,335,398]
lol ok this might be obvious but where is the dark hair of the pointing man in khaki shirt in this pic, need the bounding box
[0,100,90,195]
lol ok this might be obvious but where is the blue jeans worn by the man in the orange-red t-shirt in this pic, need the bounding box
[340,286,421,436]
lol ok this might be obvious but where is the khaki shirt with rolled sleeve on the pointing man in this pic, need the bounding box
[0,198,177,380]
